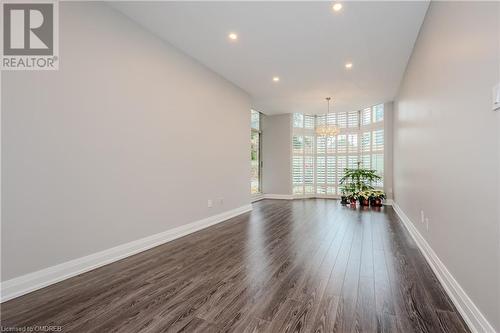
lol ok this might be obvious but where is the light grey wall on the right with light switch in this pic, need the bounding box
[394,2,500,331]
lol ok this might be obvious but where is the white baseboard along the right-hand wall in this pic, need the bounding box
[392,202,495,333]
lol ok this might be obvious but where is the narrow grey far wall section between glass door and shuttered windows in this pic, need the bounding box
[262,114,292,195]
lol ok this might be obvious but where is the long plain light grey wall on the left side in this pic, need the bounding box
[1,2,250,281]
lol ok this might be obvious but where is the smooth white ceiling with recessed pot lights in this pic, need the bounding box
[112,2,429,114]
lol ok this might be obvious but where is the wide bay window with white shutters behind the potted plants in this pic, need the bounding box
[292,104,384,196]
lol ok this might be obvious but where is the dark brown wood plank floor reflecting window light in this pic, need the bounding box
[1,199,468,333]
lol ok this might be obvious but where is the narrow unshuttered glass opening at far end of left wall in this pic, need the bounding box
[250,110,262,194]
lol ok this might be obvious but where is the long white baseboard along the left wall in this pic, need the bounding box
[0,204,252,302]
